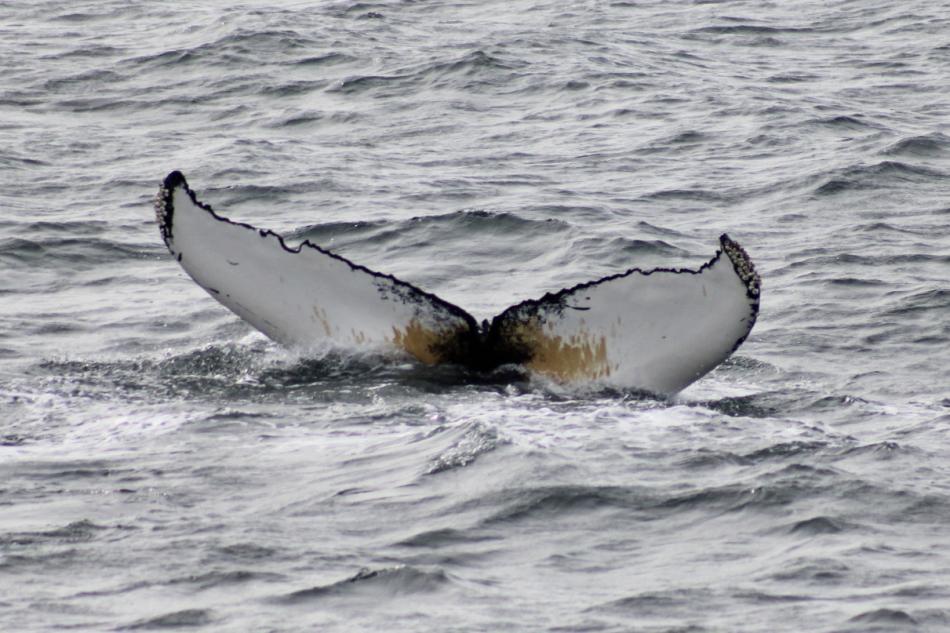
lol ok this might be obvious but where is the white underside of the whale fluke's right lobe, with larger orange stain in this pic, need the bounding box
[498,238,758,394]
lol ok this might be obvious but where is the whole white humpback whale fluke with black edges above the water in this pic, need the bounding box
[155,171,760,394]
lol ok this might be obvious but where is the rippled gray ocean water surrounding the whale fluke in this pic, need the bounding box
[0,0,950,632]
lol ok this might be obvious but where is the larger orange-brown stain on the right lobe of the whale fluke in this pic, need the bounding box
[514,319,612,382]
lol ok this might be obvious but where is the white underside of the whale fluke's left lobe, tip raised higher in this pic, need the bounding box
[160,173,480,362]
